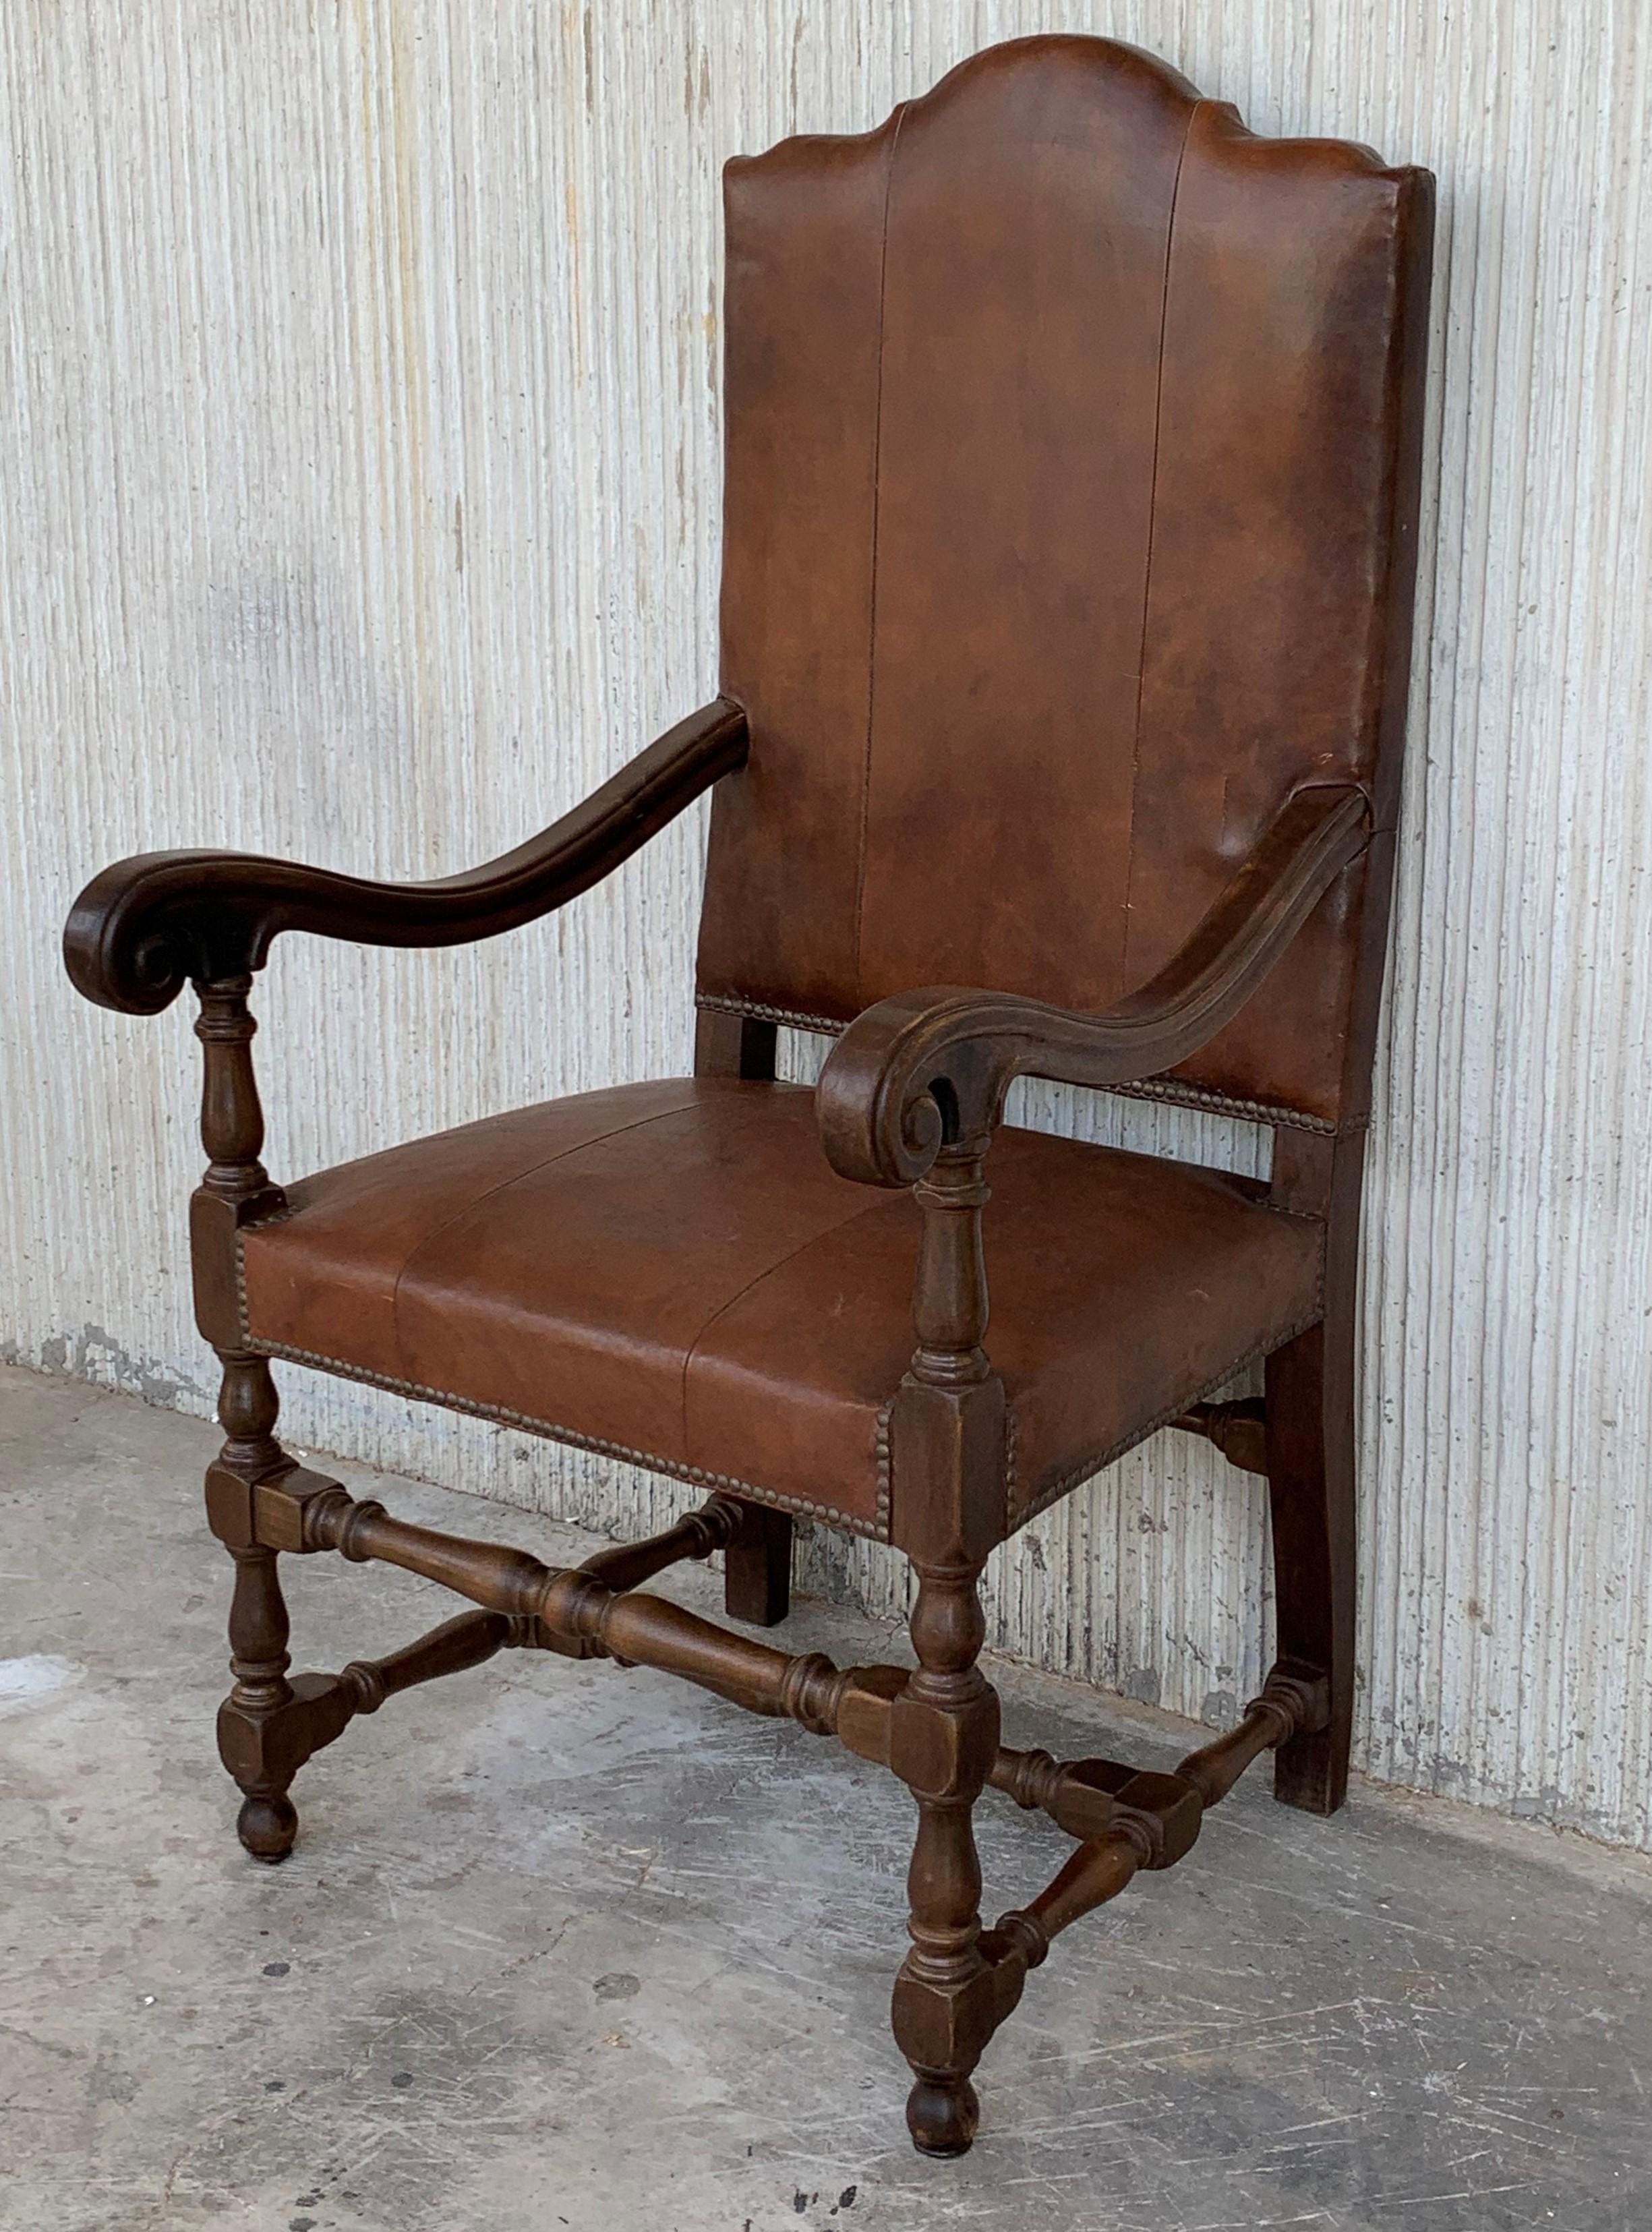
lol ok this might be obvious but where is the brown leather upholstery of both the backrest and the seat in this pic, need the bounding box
[229,38,1429,1571]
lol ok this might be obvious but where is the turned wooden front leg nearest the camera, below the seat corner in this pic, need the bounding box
[891,1567,998,2154]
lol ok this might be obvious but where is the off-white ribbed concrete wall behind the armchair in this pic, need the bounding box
[0,0,1652,1844]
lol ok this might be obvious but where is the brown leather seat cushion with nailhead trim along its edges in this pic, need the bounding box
[241,1078,1322,1533]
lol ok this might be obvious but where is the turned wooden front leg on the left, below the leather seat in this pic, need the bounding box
[218,1351,299,1862]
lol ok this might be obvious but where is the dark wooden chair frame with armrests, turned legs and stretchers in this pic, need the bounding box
[65,699,1386,2154]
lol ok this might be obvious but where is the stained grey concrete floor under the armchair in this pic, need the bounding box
[0,1373,1652,2232]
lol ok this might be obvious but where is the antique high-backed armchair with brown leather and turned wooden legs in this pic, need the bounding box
[65,38,1431,2156]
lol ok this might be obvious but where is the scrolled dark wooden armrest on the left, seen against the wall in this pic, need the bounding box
[63,699,746,1016]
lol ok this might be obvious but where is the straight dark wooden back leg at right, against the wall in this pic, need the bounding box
[1266,1310,1355,1815]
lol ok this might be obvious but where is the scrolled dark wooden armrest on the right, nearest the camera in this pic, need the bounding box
[815,784,1371,1185]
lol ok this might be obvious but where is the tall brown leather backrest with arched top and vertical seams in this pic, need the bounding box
[699,38,1431,1127]
